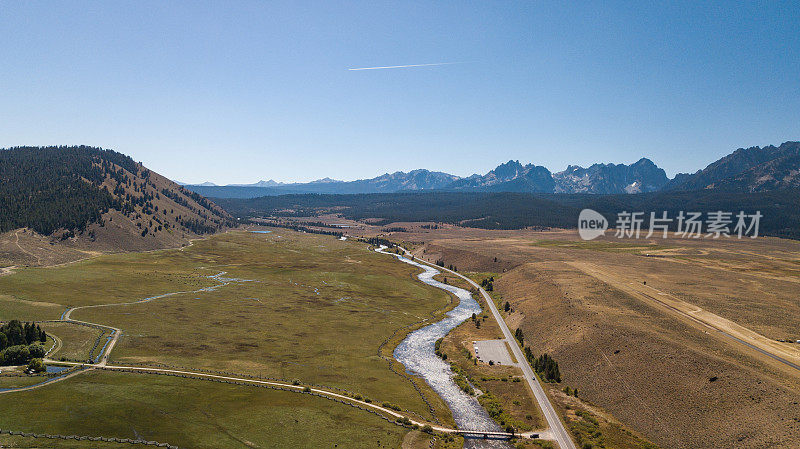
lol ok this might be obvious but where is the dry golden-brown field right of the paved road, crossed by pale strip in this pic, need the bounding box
[322,223,800,448]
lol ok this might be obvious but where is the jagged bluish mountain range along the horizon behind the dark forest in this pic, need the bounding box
[186,142,800,198]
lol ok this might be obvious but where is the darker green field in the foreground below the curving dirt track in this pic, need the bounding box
[0,371,406,448]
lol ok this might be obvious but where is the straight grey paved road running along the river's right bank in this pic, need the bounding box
[403,249,576,449]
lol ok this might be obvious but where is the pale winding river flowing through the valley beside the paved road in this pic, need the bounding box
[376,246,509,448]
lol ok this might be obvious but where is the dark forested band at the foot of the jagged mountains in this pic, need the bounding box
[215,190,800,238]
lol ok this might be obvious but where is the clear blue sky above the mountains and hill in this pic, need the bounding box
[0,1,800,183]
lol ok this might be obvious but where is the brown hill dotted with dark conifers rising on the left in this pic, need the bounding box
[0,146,233,265]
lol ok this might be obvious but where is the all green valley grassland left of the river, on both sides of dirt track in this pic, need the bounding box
[0,230,452,447]
